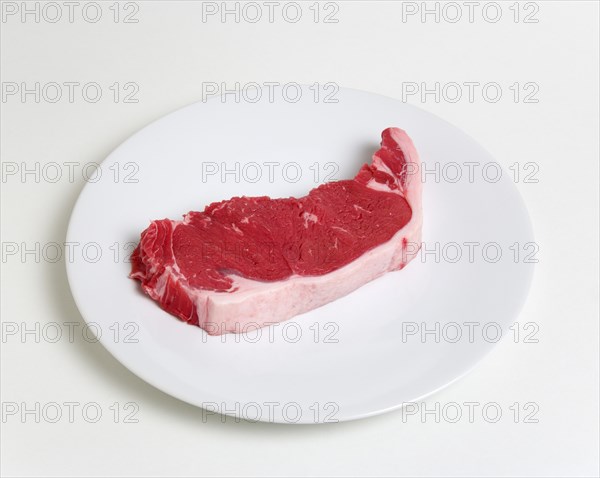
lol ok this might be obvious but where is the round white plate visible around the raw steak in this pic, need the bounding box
[67,88,534,423]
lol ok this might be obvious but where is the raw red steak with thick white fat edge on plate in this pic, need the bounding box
[130,128,422,335]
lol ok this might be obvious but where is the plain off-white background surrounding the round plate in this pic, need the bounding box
[1,1,599,476]
